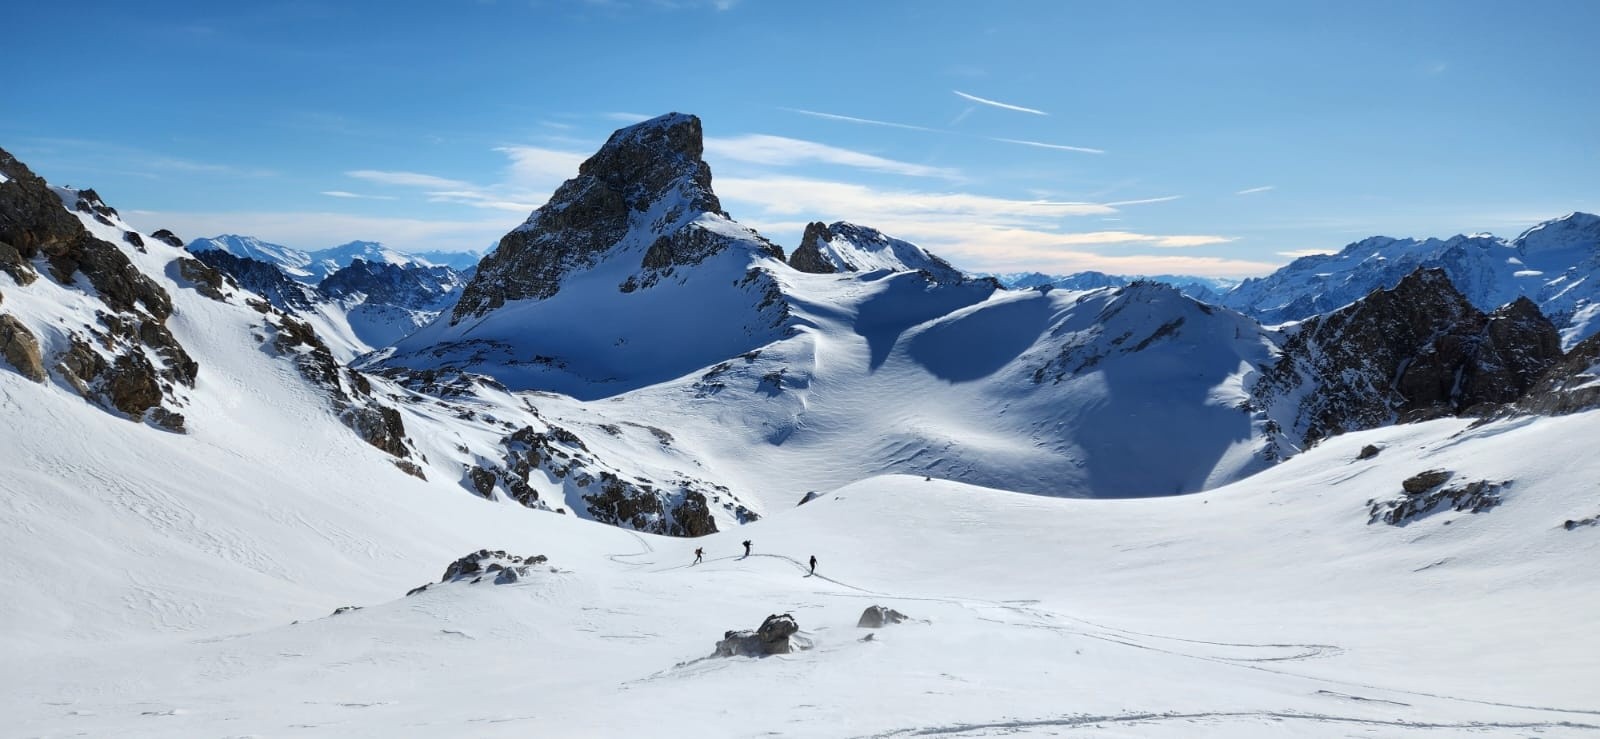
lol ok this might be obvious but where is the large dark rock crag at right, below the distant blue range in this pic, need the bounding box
[1253,269,1562,446]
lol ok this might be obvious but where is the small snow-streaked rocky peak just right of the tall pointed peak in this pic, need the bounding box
[789,221,966,282]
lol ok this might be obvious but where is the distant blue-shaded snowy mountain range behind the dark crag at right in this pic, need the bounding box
[1222,213,1600,347]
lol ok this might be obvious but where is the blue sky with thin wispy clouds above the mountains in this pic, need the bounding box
[0,0,1600,277]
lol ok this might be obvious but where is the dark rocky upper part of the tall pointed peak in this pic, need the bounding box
[451,114,782,323]
